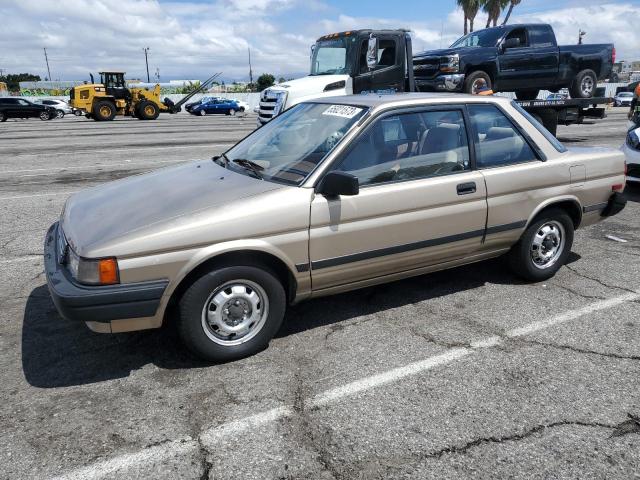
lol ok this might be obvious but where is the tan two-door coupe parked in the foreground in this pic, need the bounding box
[44,94,625,361]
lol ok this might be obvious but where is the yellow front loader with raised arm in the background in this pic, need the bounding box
[70,72,220,121]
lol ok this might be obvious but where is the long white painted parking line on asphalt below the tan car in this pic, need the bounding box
[51,293,640,480]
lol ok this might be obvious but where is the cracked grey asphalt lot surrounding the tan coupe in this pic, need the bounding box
[0,109,640,479]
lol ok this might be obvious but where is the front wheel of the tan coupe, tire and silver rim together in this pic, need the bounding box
[178,266,286,362]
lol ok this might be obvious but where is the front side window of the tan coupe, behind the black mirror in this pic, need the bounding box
[336,110,470,186]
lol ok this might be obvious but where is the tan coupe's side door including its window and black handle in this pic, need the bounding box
[309,106,487,291]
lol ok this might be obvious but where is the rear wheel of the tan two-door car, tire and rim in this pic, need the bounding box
[507,208,573,282]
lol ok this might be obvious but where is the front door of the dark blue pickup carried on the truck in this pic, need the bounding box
[498,27,534,90]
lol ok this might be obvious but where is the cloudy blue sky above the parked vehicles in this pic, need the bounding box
[0,0,640,83]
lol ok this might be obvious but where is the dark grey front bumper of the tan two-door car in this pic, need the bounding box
[44,222,169,322]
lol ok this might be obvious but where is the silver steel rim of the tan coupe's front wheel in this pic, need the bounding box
[202,280,269,346]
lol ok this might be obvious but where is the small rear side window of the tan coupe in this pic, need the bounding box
[468,105,538,168]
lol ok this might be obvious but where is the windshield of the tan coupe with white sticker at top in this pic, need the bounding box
[226,103,366,185]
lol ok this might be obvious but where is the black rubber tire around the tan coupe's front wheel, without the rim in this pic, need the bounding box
[178,266,286,362]
